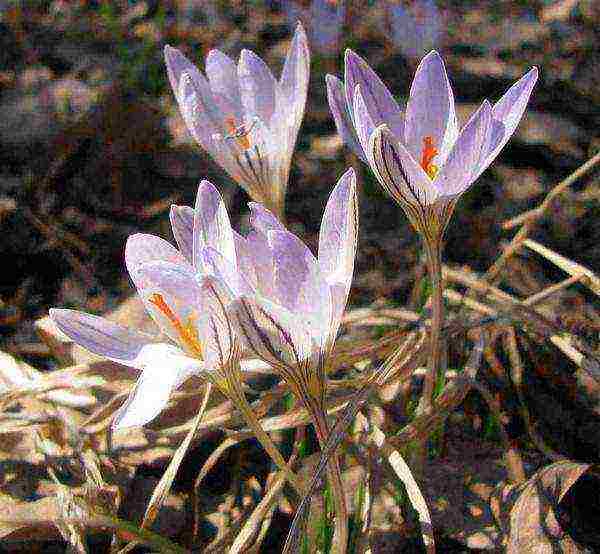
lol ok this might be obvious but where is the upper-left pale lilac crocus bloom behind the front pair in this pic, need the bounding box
[165,25,310,216]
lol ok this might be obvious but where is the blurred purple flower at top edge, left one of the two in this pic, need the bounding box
[282,0,346,56]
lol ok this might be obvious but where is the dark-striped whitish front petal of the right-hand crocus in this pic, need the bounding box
[369,125,437,210]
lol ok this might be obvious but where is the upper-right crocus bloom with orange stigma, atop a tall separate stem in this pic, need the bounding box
[327,50,537,241]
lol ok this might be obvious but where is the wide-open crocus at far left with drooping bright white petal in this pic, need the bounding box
[50,181,252,428]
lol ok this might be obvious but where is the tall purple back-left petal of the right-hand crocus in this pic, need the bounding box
[344,49,404,140]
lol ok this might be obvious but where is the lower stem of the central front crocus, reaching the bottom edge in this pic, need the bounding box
[306,398,348,554]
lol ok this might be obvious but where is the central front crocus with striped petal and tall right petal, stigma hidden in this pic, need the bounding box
[229,169,358,410]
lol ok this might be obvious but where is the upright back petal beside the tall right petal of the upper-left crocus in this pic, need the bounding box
[238,50,277,125]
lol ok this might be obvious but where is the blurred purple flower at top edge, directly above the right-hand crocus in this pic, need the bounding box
[387,0,441,59]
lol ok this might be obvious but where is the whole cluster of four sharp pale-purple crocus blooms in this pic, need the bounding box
[51,19,537,544]
